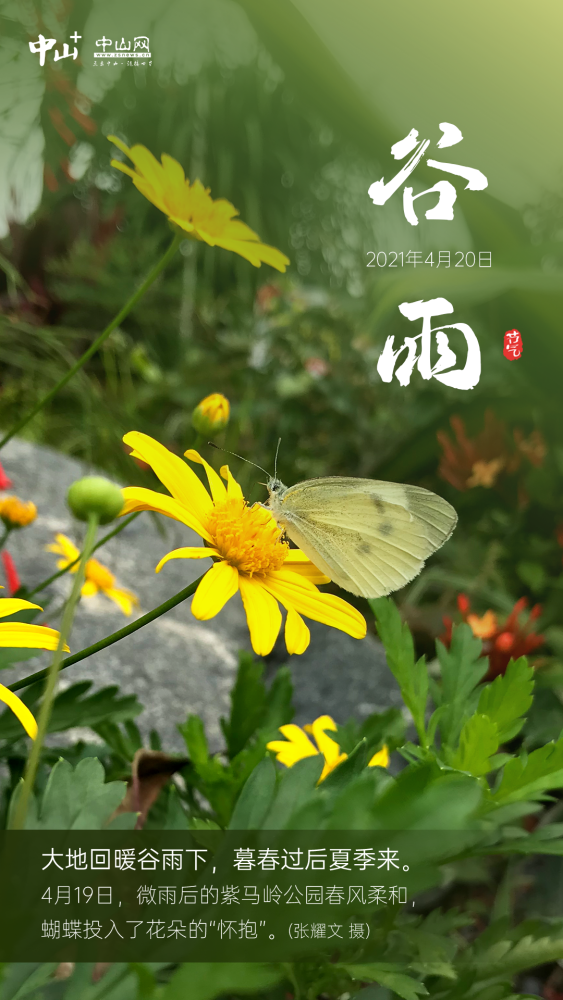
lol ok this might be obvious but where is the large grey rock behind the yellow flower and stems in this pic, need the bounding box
[1,440,401,750]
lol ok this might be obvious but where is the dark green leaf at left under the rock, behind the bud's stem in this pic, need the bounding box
[0,681,143,740]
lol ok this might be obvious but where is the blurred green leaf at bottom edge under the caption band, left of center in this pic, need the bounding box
[159,962,284,1000]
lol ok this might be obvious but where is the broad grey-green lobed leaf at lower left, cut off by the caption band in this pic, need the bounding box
[10,757,126,830]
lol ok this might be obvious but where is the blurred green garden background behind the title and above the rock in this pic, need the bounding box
[0,0,563,672]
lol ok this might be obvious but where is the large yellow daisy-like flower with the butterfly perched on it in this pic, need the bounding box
[121,431,366,656]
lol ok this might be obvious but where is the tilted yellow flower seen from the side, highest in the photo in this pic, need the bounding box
[108,135,289,272]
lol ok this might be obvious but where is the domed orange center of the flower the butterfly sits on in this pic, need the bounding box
[207,497,289,576]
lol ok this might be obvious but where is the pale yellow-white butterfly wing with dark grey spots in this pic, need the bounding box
[270,476,457,597]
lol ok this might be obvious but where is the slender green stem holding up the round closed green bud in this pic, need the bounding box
[12,514,98,830]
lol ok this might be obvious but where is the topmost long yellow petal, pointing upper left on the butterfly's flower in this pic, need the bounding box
[123,431,212,524]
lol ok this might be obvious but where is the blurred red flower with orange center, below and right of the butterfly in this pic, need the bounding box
[440,594,544,681]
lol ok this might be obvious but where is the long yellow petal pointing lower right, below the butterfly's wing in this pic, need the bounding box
[264,569,367,639]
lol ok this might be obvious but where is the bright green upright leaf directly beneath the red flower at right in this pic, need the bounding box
[477,656,534,744]
